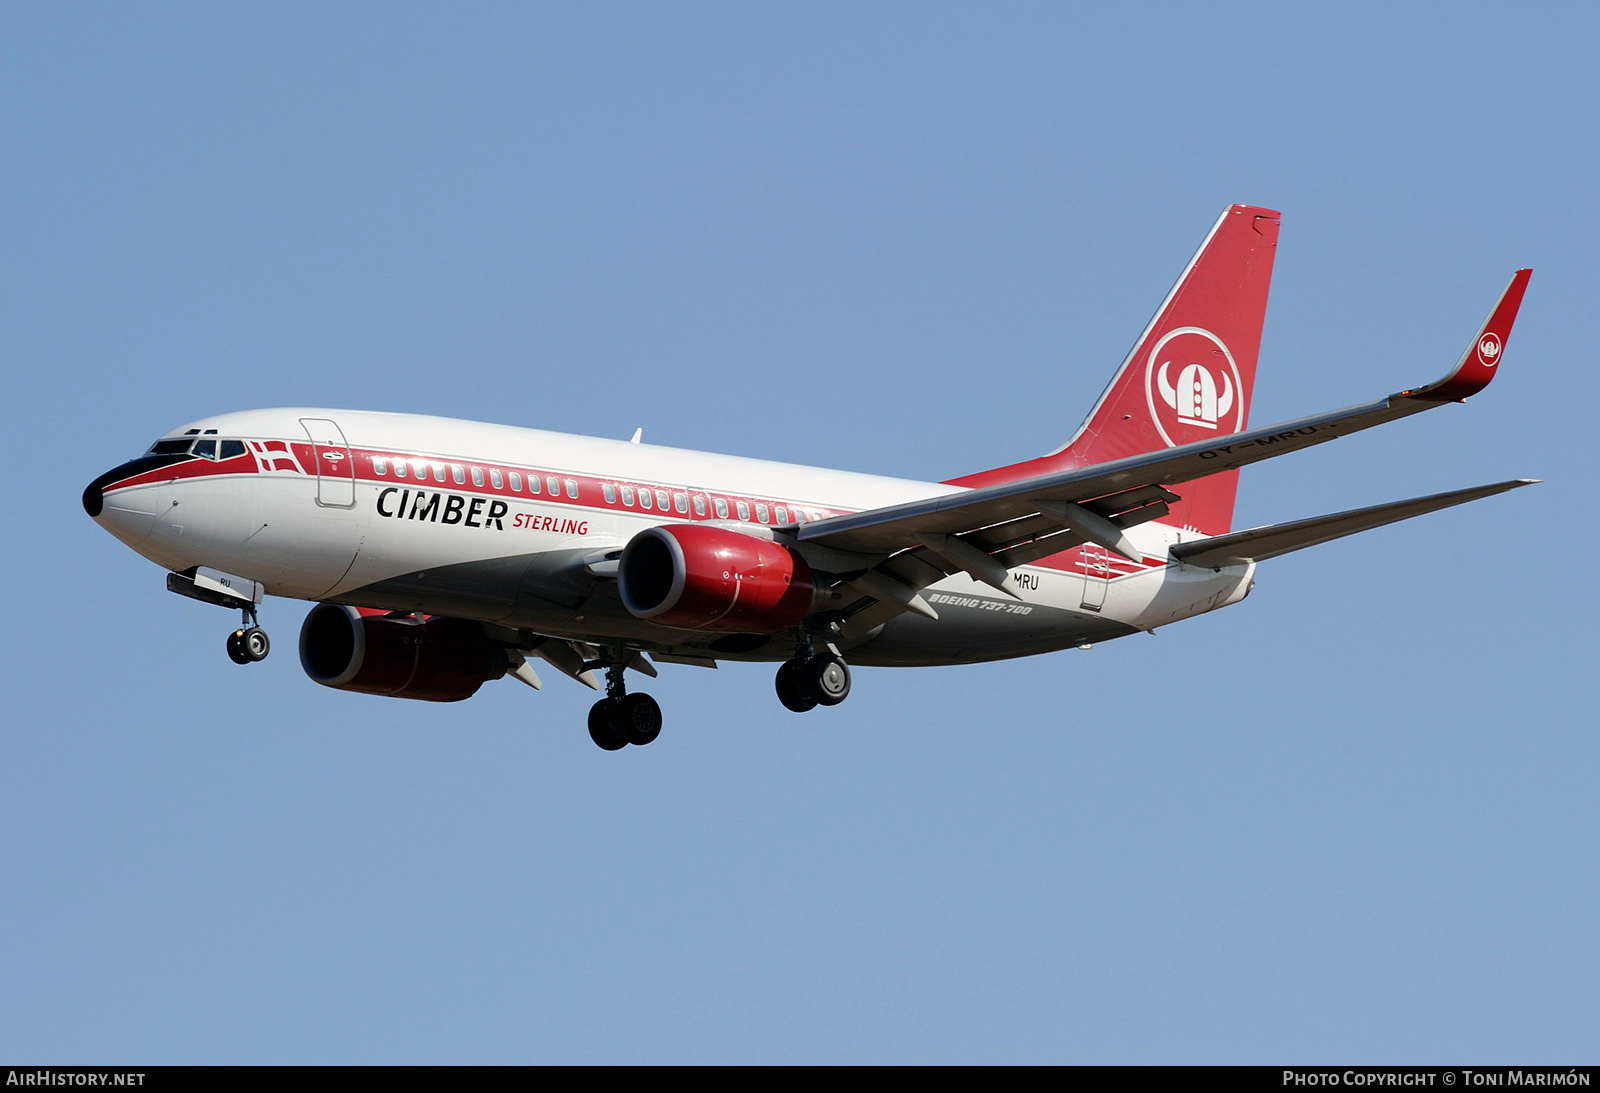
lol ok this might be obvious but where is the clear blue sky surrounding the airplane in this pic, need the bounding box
[0,5,1600,1064]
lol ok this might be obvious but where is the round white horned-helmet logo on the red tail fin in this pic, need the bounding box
[1144,326,1245,446]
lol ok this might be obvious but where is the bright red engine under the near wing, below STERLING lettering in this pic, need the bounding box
[616,523,816,634]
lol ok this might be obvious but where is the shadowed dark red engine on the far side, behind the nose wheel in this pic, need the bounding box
[301,603,510,703]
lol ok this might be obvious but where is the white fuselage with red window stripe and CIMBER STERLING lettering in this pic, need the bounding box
[98,410,1253,664]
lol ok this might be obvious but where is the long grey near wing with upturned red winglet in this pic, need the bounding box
[795,269,1533,631]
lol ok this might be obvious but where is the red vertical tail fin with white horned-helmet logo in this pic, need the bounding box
[949,205,1278,534]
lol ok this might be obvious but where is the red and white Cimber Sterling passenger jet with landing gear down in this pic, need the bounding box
[83,205,1531,751]
